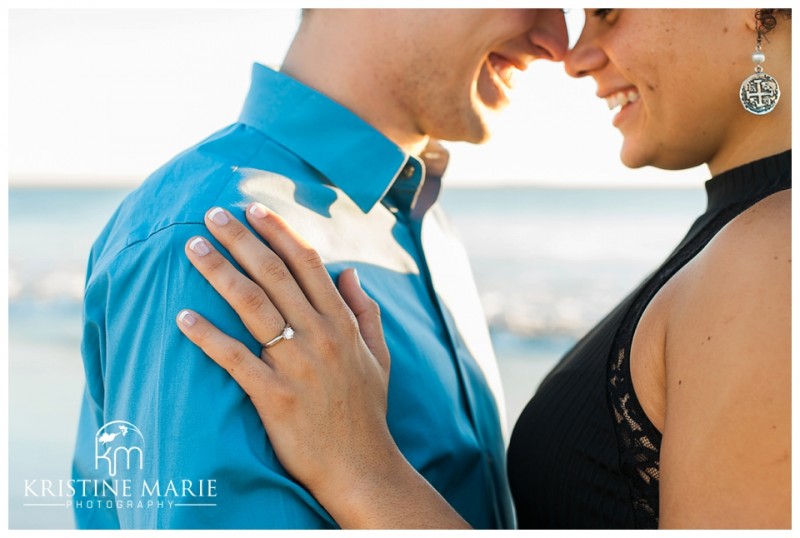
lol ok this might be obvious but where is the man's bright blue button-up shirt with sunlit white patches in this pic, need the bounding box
[72,65,513,528]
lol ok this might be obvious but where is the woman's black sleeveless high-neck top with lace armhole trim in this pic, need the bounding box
[508,150,792,529]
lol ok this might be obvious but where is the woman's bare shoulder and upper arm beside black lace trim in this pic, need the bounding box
[660,192,792,528]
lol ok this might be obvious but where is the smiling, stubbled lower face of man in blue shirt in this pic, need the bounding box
[376,9,567,143]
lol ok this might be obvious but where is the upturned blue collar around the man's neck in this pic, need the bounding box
[239,64,416,213]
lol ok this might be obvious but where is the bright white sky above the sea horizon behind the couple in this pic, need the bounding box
[8,3,708,187]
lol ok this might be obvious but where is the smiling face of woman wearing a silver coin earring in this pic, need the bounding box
[565,9,769,170]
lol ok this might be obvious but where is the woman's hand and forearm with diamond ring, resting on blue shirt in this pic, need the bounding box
[178,204,467,528]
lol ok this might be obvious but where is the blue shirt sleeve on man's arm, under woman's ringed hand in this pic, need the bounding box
[73,224,336,529]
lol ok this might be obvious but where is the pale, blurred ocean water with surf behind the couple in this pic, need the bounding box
[8,186,705,528]
